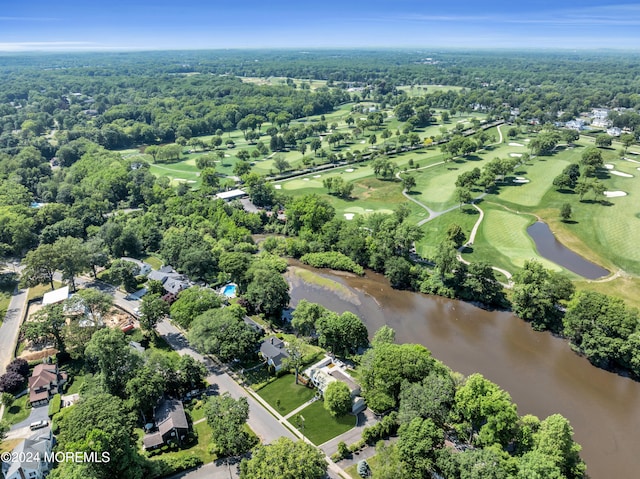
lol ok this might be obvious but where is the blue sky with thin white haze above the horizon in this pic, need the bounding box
[0,0,640,51]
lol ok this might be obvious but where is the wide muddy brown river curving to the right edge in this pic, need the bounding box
[288,261,640,479]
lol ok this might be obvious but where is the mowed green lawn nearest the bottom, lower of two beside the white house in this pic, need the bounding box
[296,401,356,446]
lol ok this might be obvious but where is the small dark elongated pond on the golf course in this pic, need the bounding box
[527,221,609,279]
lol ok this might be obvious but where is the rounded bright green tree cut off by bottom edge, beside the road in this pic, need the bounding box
[240,437,327,479]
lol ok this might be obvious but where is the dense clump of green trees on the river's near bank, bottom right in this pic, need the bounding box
[358,327,586,479]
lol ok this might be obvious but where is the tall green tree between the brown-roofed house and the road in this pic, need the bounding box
[204,393,251,457]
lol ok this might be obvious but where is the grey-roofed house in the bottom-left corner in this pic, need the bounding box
[2,431,53,479]
